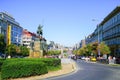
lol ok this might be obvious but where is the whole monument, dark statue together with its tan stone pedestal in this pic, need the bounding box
[29,25,43,58]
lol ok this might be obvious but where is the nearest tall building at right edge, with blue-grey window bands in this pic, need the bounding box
[101,6,120,56]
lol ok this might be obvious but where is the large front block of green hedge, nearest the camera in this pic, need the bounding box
[1,61,48,79]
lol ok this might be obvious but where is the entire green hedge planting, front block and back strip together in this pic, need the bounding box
[1,58,61,79]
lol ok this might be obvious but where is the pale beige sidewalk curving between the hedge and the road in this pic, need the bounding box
[11,59,76,80]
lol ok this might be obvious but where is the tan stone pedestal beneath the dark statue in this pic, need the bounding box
[29,41,43,58]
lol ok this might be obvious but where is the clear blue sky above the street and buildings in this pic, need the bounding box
[0,0,120,46]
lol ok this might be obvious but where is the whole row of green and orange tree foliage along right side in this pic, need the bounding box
[73,42,110,56]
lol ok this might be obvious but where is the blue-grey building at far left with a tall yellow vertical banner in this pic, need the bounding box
[0,12,23,45]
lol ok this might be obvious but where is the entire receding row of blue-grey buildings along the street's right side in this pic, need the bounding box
[86,6,120,57]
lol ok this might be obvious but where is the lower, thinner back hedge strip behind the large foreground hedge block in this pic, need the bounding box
[6,58,61,71]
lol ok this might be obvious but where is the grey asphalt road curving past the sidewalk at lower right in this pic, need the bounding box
[45,60,120,80]
